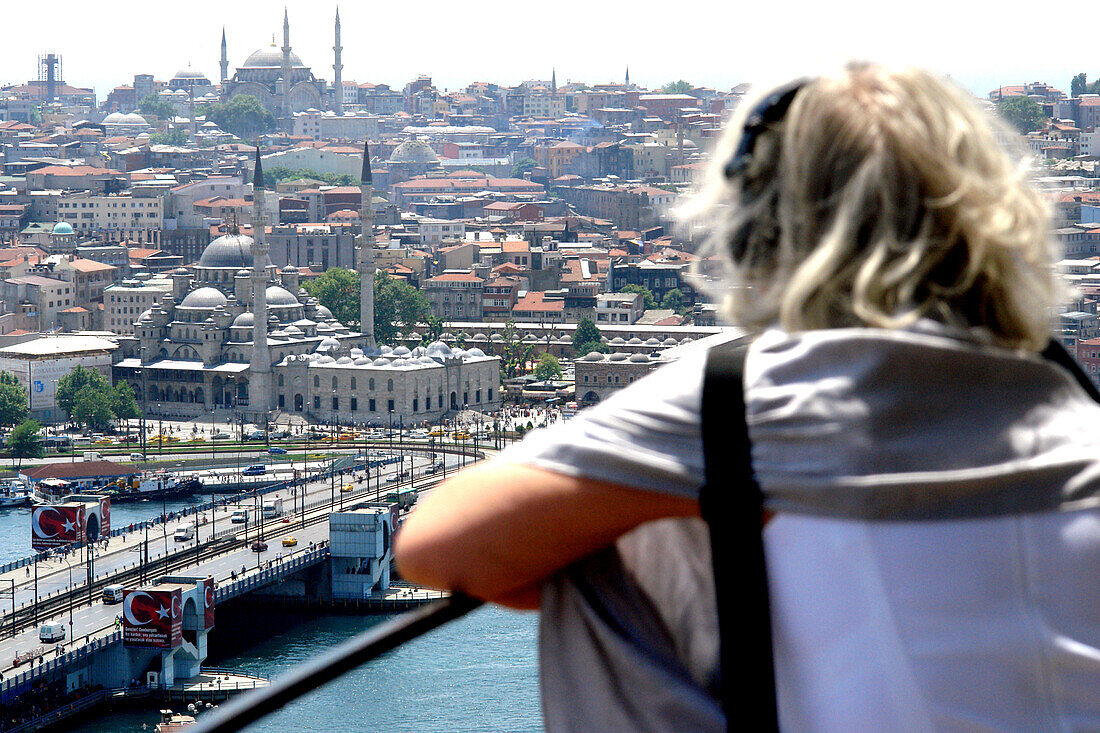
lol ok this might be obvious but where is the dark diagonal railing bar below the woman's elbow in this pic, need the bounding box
[188,594,481,733]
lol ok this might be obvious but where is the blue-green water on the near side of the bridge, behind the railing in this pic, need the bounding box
[66,608,541,733]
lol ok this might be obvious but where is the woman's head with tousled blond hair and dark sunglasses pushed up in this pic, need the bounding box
[699,64,1056,349]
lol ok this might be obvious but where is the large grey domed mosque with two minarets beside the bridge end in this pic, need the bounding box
[113,143,501,425]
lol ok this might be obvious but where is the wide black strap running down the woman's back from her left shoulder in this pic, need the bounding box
[699,343,779,731]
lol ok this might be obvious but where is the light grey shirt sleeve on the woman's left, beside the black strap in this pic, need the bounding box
[497,349,707,497]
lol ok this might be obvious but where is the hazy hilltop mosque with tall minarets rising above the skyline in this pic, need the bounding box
[220,10,343,119]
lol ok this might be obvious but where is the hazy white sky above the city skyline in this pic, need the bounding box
[0,0,1082,99]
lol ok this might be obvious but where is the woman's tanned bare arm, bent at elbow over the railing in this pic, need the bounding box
[395,462,699,608]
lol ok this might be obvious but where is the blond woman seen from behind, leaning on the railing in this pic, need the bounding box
[395,64,1100,733]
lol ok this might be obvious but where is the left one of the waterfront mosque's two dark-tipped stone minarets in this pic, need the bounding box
[249,145,272,411]
